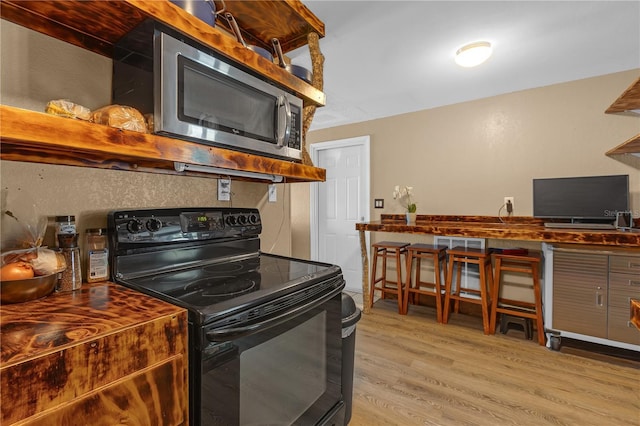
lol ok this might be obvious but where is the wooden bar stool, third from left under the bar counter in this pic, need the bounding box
[442,247,493,334]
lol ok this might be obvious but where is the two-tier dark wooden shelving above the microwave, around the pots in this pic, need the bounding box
[0,0,326,106]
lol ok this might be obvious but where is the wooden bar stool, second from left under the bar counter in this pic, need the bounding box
[402,244,447,322]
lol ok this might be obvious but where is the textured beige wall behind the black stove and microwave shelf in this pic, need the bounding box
[0,20,291,255]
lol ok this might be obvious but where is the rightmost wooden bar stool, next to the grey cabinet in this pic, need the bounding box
[490,251,545,346]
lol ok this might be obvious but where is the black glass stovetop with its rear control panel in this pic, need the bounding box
[108,208,341,326]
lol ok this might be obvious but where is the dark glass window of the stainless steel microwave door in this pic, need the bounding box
[178,56,276,143]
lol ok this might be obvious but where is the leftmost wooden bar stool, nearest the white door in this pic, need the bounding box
[370,241,409,313]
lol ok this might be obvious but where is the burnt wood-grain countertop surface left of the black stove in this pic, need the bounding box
[0,282,186,369]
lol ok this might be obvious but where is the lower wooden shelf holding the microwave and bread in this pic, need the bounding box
[0,105,326,182]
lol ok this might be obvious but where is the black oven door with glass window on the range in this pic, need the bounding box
[192,287,344,426]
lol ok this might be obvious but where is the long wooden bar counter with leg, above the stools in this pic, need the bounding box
[356,214,640,313]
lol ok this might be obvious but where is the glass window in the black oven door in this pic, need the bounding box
[240,311,327,425]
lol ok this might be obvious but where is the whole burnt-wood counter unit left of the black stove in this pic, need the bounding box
[0,283,189,425]
